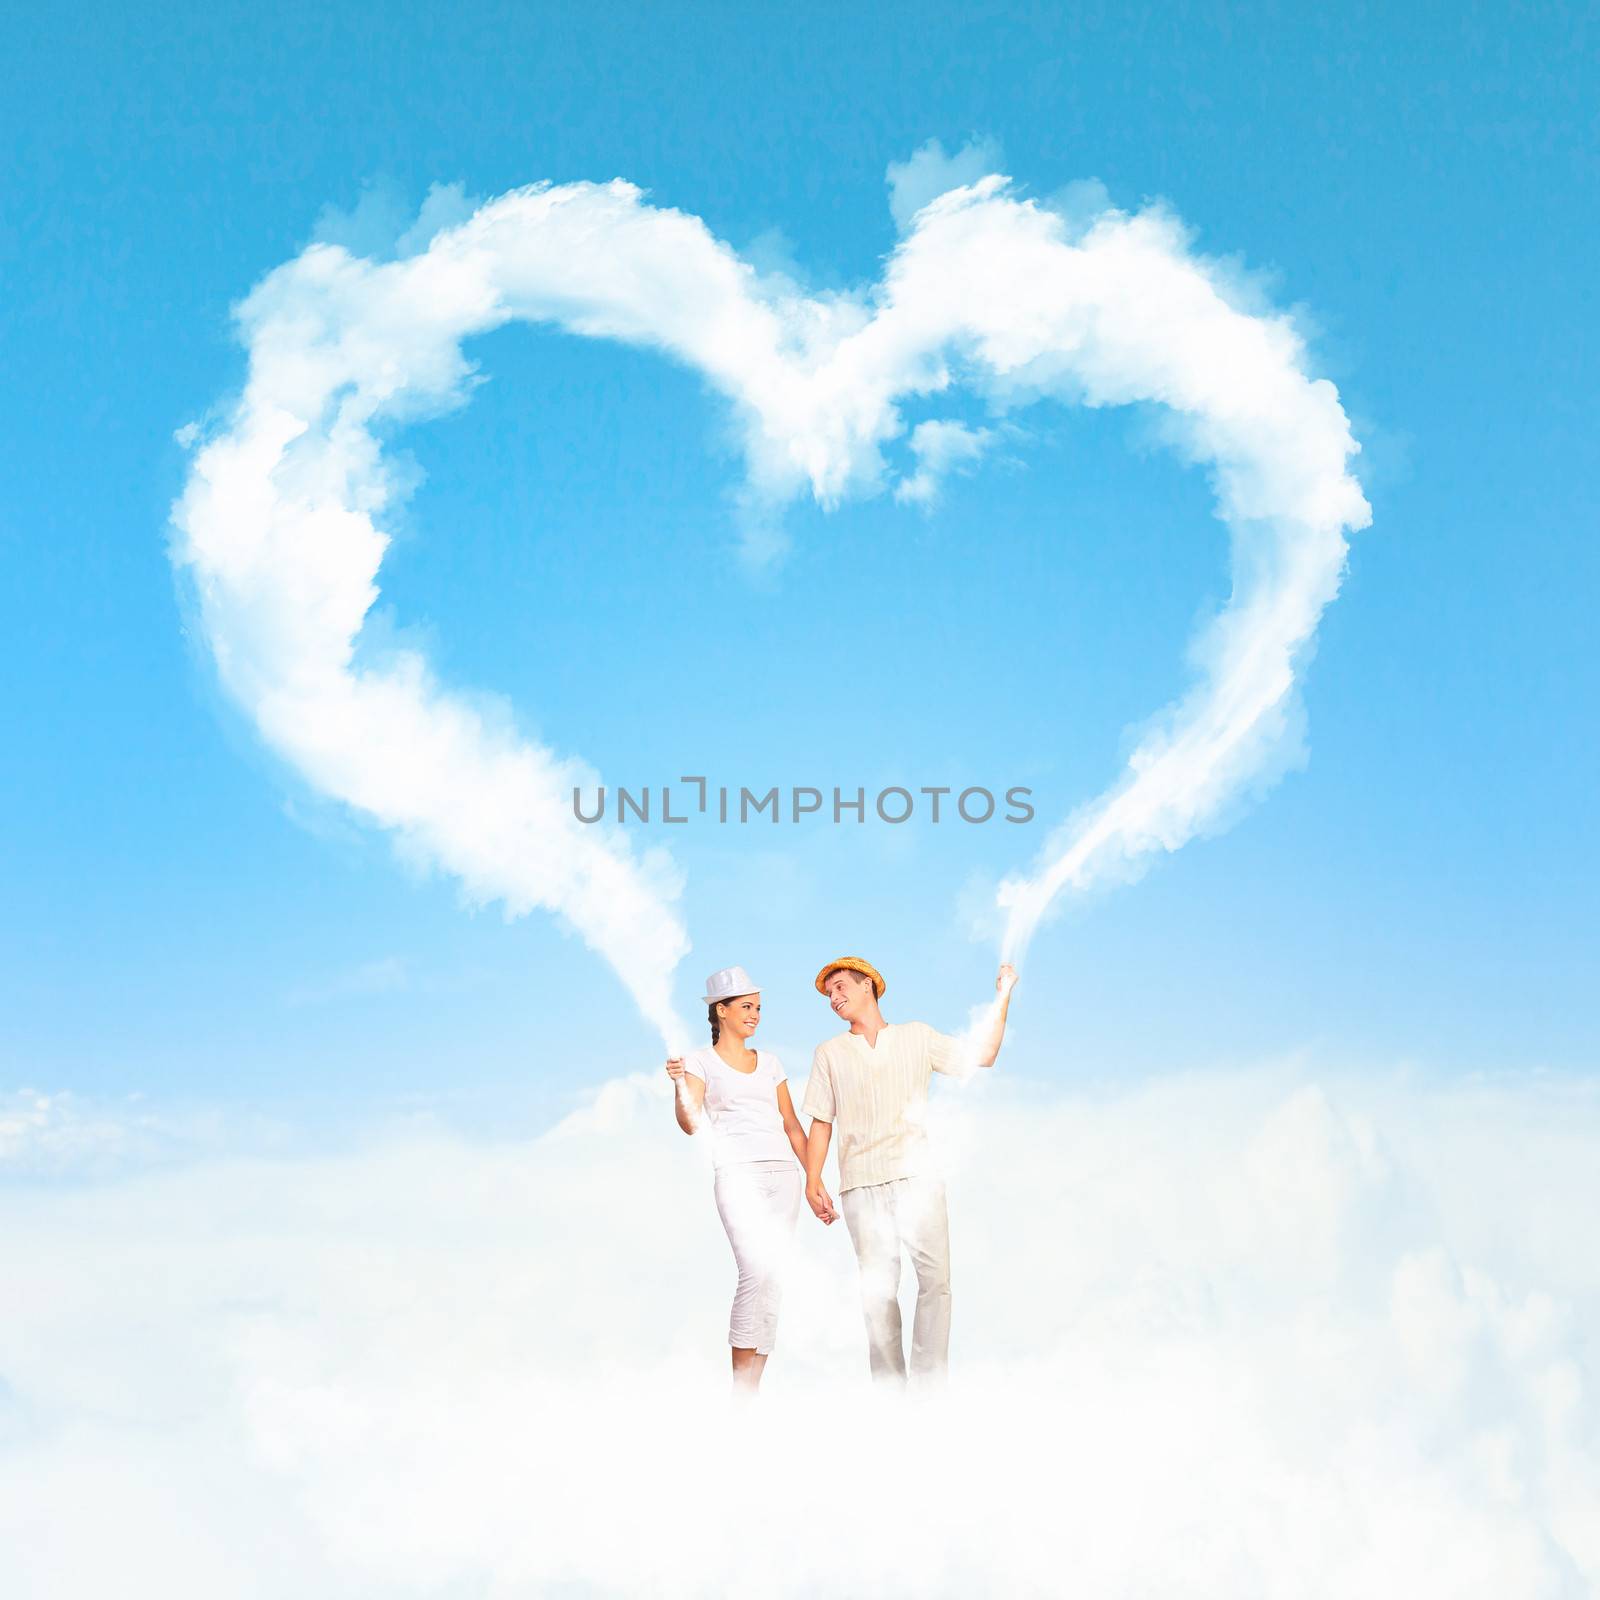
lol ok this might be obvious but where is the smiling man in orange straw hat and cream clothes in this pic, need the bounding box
[803,955,1016,1384]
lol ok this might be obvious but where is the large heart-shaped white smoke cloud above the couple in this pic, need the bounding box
[173,165,1370,1045]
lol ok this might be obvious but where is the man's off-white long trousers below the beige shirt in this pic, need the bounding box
[838,1178,950,1384]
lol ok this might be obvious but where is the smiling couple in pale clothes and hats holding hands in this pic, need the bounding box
[667,955,1016,1394]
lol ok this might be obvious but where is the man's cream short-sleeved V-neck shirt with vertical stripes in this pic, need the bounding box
[803,1022,957,1194]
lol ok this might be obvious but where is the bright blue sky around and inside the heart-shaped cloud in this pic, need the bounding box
[0,5,1600,1132]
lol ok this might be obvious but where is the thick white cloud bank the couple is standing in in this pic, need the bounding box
[0,1064,1600,1600]
